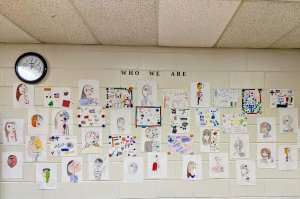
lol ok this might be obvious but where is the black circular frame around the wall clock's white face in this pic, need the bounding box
[15,52,48,84]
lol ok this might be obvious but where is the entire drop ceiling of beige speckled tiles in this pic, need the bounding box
[0,0,300,48]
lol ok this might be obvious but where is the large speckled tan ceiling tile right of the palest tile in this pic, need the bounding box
[216,0,300,48]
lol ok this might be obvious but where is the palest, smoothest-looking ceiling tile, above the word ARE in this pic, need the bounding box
[159,0,240,47]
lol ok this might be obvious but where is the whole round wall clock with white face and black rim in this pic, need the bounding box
[15,52,47,84]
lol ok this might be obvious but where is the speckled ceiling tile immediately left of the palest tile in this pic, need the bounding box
[73,0,157,45]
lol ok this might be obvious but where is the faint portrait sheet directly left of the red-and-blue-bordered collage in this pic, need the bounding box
[110,108,131,134]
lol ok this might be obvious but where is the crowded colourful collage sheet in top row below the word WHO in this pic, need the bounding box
[106,87,133,108]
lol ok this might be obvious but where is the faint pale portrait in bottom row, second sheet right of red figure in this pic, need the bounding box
[208,153,229,178]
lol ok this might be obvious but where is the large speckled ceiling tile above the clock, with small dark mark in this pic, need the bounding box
[0,0,97,44]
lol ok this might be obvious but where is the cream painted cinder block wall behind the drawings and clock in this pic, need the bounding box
[0,44,300,199]
